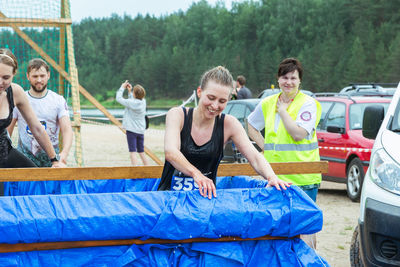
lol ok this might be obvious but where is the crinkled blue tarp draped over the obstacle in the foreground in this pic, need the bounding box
[0,177,328,266]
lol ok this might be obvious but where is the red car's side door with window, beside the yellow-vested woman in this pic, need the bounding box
[317,101,346,179]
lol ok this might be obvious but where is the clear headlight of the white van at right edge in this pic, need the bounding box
[369,149,400,195]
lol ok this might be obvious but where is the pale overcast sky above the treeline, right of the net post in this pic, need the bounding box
[69,0,241,22]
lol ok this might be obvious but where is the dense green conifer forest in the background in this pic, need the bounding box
[1,0,400,101]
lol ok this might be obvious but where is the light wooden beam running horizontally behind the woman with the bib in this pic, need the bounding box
[0,161,328,182]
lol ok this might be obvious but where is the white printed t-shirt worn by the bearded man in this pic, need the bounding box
[13,90,69,155]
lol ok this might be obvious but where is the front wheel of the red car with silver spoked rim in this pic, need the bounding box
[347,158,365,201]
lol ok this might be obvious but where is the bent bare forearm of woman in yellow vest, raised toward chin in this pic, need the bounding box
[276,99,308,141]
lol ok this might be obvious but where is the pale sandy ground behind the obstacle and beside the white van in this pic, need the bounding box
[65,124,359,267]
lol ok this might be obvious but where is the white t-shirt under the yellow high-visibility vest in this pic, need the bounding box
[247,99,317,139]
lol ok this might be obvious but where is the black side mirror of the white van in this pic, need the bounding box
[363,105,385,139]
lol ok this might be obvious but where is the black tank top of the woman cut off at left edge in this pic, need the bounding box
[0,86,14,161]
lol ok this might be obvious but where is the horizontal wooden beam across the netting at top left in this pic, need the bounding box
[0,17,72,27]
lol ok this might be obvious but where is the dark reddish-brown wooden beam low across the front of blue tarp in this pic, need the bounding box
[0,236,299,253]
